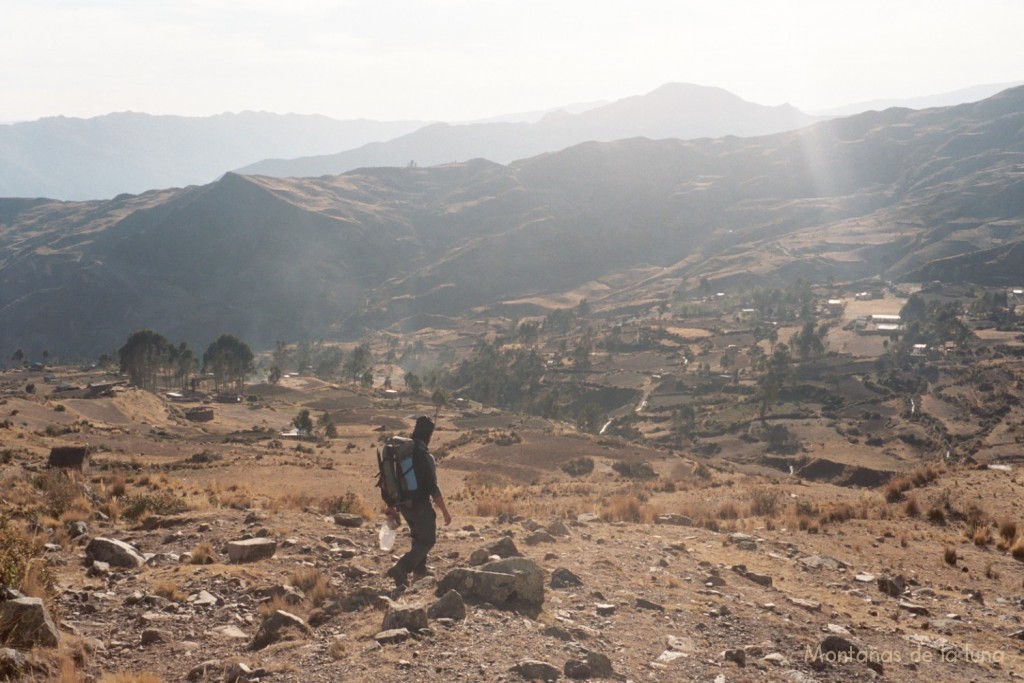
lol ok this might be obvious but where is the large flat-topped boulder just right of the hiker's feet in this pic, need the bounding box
[437,557,544,607]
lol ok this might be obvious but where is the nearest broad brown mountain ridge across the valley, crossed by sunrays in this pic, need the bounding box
[0,88,1024,356]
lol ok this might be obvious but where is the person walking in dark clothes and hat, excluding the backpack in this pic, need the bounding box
[387,415,452,588]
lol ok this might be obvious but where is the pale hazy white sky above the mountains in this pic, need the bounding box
[0,0,1024,122]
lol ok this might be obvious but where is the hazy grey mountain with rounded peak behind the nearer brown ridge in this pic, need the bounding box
[238,84,820,178]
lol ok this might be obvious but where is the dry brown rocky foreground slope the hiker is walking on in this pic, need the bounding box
[0,366,1024,683]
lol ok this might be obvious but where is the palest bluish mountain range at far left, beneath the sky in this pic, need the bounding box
[0,112,424,200]
